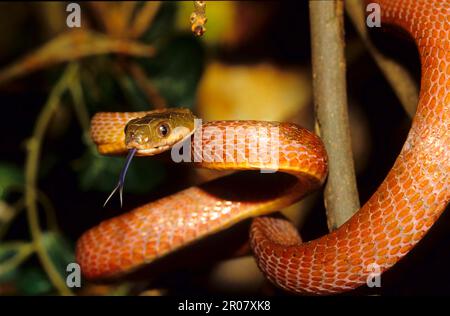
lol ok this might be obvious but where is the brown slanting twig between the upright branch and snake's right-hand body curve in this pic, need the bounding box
[345,0,419,118]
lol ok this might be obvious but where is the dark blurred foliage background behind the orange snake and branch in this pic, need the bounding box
[0,1,450,295]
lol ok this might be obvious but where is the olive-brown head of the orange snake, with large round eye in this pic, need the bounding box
[124,109,195,156]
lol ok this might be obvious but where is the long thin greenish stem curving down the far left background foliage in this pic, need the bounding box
[25,64,77,295]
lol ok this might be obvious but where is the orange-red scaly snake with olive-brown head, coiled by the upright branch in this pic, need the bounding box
[76,0,450,295]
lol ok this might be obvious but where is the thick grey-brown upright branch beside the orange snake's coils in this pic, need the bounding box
[309,0,359,230]
